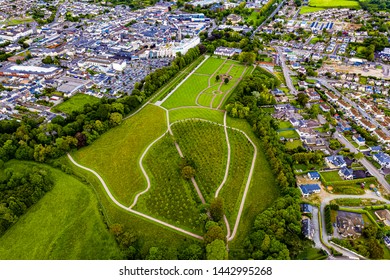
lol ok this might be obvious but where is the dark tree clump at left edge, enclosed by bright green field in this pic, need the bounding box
[0,162,53,235]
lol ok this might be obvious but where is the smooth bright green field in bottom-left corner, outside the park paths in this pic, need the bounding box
[0,160,122,260]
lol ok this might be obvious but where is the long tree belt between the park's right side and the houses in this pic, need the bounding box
[227,61,314,259]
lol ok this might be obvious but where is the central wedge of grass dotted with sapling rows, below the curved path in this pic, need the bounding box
[172,120,227,202]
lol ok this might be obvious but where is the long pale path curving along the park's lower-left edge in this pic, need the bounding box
[68,154,203,240]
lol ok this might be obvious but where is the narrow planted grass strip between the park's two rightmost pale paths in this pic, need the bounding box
[220,129,254,227]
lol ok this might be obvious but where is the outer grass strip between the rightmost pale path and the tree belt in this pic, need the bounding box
[227,117,279,254]
